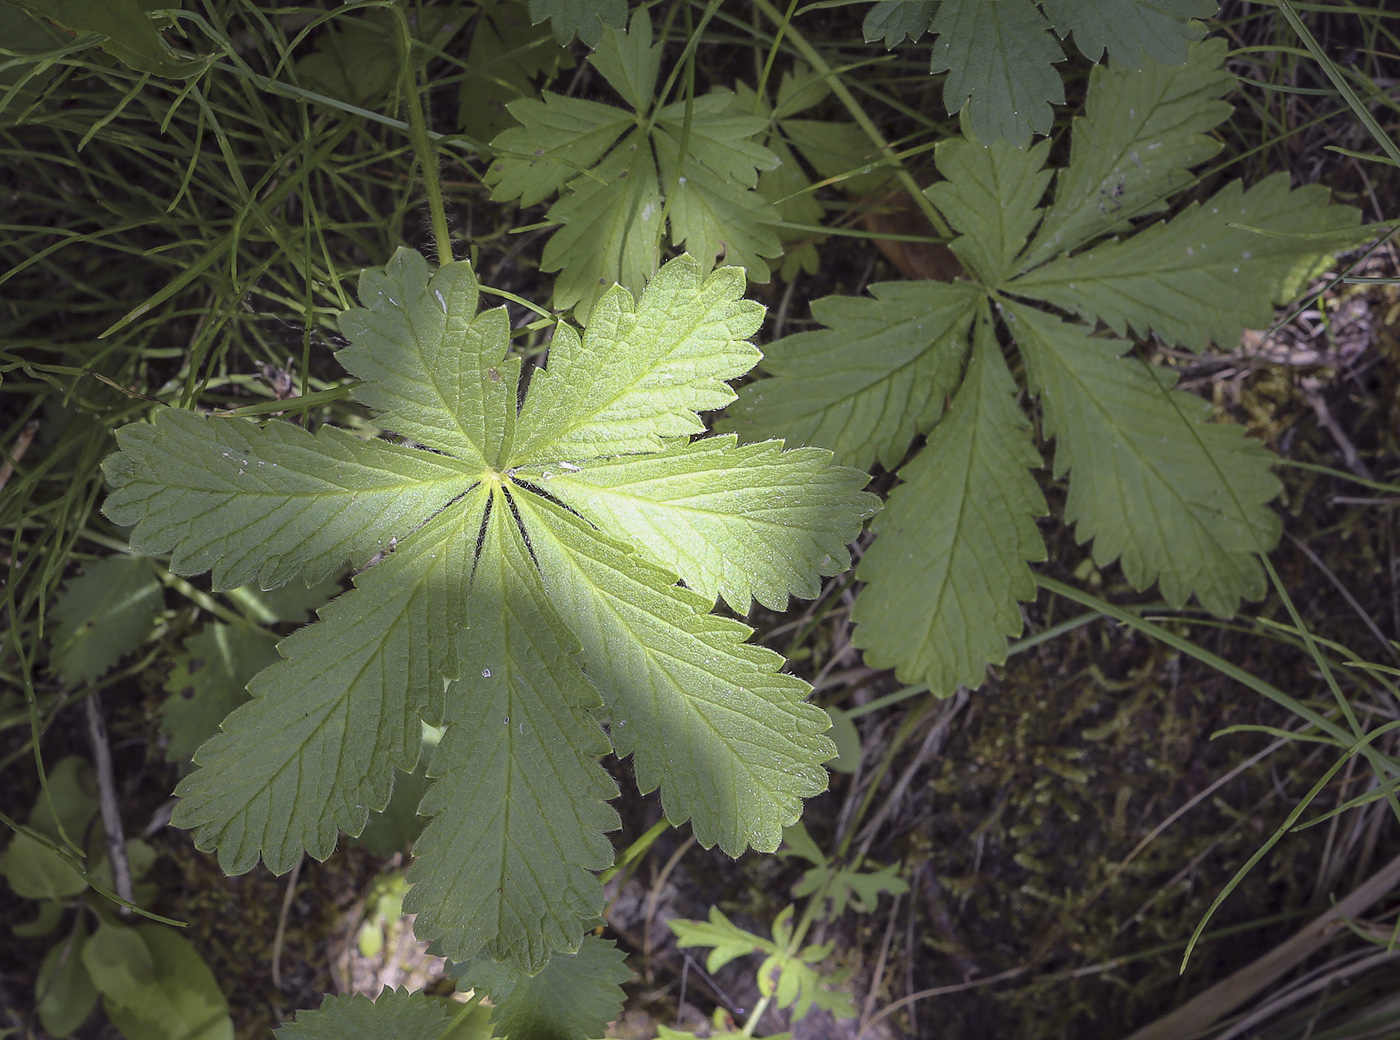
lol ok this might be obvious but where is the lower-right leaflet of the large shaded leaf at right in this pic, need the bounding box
[1005,302,1281,617]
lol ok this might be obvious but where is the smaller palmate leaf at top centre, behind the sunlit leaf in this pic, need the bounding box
[486,10,783,321]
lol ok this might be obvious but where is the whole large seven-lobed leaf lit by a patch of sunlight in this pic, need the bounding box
[105,251,878,973]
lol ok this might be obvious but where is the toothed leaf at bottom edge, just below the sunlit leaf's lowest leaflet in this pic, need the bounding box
[451,935,633,1040]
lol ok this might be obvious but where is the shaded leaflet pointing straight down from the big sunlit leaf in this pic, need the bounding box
[405,491,619,973]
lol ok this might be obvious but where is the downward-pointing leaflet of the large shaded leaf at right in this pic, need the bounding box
[851,311,1047,690]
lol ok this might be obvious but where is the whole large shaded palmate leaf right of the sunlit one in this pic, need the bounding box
[721,41,1364,693]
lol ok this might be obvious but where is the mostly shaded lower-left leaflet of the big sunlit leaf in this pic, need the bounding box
[172,501,486,873]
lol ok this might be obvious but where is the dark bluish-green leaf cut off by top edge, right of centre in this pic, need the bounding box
[864,0,1218,146]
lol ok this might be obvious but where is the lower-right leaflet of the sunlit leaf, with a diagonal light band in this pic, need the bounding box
[519,496,836,855]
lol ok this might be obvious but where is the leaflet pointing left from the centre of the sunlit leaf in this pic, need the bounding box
[102,409,475,591]
